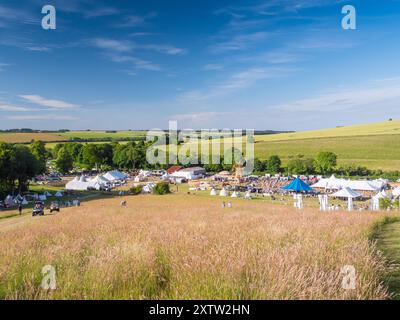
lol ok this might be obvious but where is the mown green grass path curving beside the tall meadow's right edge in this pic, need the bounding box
[377,221,400,300]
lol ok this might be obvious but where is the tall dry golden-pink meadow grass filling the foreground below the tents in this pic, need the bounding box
[0,195,388,299]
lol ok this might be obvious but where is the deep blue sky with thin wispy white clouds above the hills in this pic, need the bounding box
[0,0,400,130]
